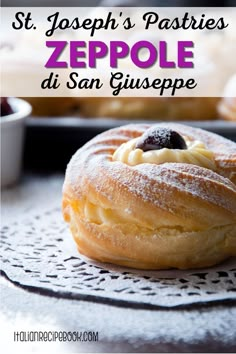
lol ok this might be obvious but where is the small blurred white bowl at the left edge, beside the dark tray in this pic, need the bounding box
[0,98,31,188]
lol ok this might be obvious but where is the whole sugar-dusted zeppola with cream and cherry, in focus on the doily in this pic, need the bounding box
[63,123,236,269]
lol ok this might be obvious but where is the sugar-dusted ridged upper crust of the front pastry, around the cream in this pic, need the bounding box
[65,124,236,230]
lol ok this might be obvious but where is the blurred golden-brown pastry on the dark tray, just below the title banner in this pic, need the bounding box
[79,97,219,120]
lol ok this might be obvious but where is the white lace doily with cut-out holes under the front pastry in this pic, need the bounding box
[1,176,236,307]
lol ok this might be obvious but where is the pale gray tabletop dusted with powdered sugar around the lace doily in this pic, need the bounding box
[0,176,236,352]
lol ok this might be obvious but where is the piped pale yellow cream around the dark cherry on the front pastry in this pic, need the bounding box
[113,137,215,171]
